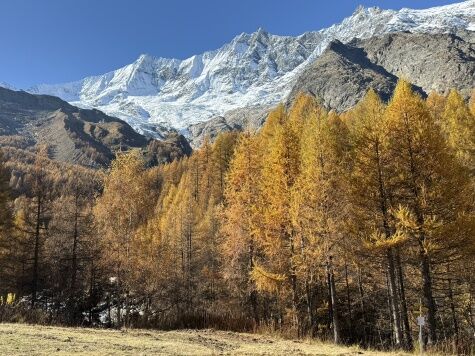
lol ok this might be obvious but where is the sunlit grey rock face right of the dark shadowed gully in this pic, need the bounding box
[356,31,475,95]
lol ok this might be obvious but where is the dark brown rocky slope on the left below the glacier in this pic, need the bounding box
[0,87,189,167]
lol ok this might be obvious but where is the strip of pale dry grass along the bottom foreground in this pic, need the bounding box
[0,324,410,355]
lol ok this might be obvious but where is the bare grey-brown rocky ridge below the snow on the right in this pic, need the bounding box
[288,32,475,111]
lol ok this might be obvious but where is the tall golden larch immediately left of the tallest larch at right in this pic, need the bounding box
[349,90,412,349]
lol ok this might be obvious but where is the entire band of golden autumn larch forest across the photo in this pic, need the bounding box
[0,81,475,352]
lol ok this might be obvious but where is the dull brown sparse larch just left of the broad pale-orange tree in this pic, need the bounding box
[46,169,100,324]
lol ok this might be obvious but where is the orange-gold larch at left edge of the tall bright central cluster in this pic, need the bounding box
[221,133,261,324]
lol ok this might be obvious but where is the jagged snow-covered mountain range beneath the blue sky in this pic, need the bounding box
[29,0,475,136]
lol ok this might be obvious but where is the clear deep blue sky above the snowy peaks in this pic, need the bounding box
[0,0,457,88]
